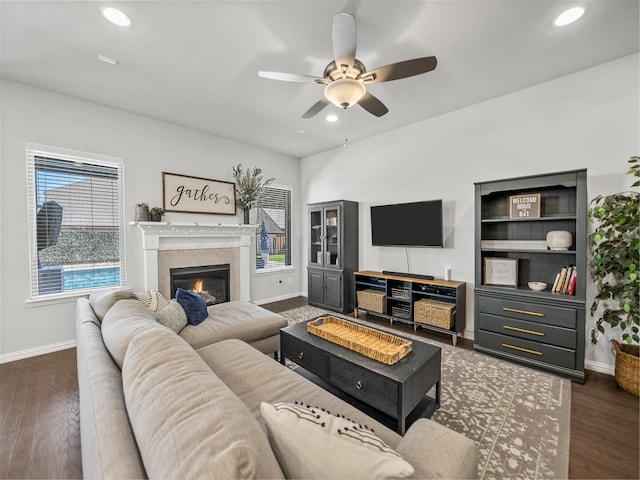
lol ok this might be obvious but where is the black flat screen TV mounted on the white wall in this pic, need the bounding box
[371,200,444,248]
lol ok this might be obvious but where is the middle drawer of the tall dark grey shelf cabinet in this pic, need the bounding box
[478,313,577,349]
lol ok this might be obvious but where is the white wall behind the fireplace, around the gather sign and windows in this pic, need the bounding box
[0,81,303,361]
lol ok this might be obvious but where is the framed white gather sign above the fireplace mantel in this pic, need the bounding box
[162,172,236,215]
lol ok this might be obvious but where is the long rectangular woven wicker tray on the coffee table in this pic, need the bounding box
[307,316,412,365]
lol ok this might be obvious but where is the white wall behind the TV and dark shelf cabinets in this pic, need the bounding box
[301,54,640,372]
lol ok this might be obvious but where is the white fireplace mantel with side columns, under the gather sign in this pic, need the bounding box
[129,222,257,300]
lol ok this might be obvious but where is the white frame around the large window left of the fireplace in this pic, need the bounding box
[25,143,127,306]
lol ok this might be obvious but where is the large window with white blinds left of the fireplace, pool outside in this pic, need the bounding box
[27,147,125,299]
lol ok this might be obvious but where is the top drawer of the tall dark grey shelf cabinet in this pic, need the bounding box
[479,296,576,328]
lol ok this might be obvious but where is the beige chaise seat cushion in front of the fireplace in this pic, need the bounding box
[180,300,287,348]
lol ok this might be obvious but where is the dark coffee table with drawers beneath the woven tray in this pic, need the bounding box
[280,320,440,435]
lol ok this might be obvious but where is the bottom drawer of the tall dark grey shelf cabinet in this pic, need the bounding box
[477,330,576,369]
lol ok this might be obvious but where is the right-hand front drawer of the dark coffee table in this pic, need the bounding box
[329,357,398,418]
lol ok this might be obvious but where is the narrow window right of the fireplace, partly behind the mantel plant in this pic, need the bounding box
[256,185,291,271]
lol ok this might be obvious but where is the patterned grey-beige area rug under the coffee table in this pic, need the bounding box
[281,306,571,479]
